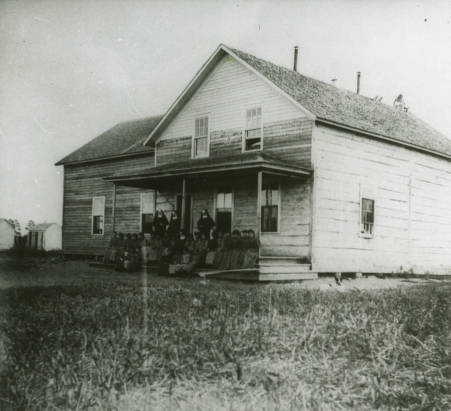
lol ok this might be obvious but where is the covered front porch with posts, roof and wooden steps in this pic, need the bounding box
[108,152,316,281]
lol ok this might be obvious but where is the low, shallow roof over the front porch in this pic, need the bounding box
[106,151,311,185]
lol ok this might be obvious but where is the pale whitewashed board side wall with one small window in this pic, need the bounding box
[312,126,451,274]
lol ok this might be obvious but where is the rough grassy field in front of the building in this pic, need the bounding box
[0,260,451,410]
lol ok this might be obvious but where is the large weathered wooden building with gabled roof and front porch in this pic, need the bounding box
[57,45,451,280]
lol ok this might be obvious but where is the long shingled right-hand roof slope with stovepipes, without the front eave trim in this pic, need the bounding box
[230,46,451,156]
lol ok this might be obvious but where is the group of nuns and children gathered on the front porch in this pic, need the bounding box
[104,209,258,274]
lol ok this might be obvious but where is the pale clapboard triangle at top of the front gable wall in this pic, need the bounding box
[160,56,304,140]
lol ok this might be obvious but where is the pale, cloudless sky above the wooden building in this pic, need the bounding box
[0,0,451,226]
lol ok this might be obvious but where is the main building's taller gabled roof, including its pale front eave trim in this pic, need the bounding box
[144,45,451,157]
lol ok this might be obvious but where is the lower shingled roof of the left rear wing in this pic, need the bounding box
[56,116,161,165]
